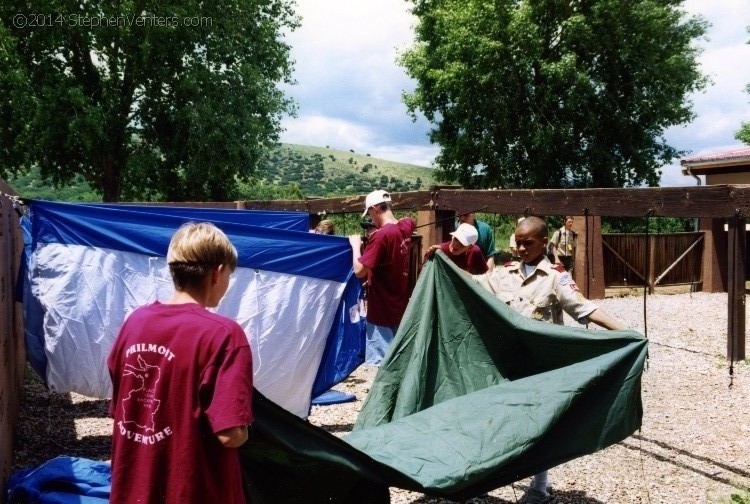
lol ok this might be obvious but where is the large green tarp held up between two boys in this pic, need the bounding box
[242,253,647,503]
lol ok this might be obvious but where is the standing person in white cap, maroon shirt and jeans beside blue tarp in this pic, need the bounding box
[349,189,417,366]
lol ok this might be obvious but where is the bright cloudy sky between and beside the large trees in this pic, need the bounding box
[281,0,750,186]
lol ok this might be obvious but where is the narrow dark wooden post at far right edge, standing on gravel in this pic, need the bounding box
[727,218,747,361]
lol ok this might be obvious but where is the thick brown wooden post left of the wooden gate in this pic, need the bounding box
[573,216,604,299]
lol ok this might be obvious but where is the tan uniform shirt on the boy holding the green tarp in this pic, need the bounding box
[472,258,597,325]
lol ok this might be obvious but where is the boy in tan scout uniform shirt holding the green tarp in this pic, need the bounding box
[472,217,624,504]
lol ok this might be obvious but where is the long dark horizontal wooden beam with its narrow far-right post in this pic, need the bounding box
[242,185,750,360]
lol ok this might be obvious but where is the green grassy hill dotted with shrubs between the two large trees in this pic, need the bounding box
[259,144,435,197]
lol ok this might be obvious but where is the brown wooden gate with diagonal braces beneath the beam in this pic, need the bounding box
[602,232,703,292]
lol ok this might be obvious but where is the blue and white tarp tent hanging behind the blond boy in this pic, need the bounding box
[22,201,364,416]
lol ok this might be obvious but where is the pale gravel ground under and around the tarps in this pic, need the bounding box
[8,292,750,504]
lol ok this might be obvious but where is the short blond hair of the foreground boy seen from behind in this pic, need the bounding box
[167,222,237,290]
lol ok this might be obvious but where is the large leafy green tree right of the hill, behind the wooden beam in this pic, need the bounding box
[399,0,708,188]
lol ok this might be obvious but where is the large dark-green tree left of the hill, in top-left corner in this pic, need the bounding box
[0,0,298,201]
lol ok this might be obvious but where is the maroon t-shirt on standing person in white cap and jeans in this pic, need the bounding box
[359,217,417,327]
